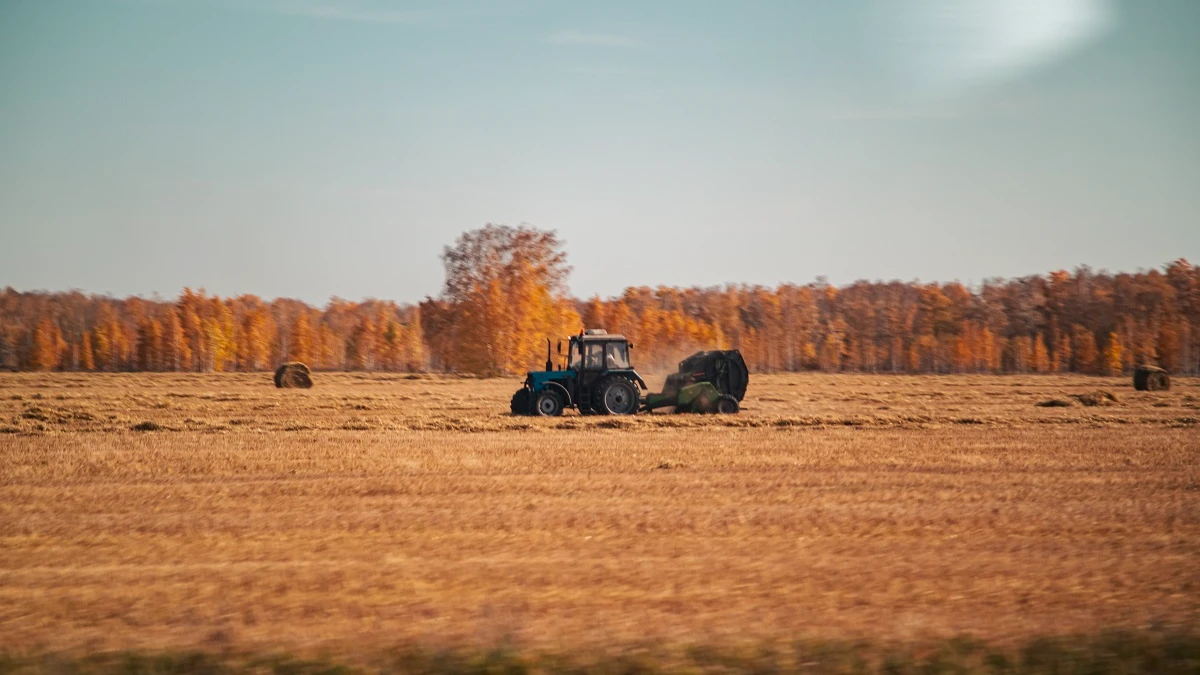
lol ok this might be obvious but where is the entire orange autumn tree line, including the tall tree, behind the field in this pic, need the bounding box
[0,225,1200,375]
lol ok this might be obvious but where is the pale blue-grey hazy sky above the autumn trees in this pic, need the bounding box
[0,0,1200,303]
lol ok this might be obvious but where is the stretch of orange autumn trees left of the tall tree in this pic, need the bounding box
[0,288,426,372]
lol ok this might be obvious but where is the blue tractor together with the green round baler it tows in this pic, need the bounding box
[510,328,749,417]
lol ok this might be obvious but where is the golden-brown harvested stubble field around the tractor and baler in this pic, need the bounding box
[0,372,1200,651]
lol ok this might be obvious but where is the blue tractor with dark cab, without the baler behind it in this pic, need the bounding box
[511,328,646,417]
